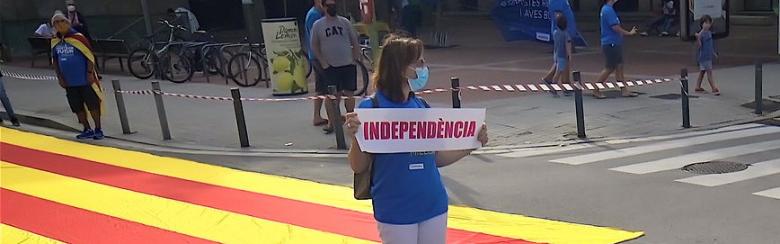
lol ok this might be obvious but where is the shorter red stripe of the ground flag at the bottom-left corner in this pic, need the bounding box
[0,188,214,243]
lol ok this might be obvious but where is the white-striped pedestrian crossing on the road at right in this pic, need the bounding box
[499,124,780,200]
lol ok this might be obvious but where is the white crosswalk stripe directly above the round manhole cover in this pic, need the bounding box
[610,140,780,174]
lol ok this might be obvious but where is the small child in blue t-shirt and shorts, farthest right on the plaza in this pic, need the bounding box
[696,15,720,96]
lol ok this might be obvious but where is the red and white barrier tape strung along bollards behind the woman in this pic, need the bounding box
[111,79,674,102]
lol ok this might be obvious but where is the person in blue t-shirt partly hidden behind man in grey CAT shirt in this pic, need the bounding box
[303,0,328,126]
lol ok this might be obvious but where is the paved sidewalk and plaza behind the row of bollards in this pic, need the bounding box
[3,17,780,152]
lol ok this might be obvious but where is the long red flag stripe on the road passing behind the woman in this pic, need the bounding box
[0,143,530,243]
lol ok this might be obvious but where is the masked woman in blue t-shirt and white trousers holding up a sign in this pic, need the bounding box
[345,35,488,244]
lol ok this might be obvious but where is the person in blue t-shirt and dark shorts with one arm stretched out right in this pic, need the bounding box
[593,0,637,99]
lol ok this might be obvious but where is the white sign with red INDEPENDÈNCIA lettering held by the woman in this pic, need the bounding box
[355,108,485,153]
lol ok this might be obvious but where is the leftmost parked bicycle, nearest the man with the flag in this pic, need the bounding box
[128,20,194,83]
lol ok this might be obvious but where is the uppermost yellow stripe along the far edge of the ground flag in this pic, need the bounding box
[0,128,643,244]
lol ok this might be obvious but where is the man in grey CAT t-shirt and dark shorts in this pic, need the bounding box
[311,0,360,133]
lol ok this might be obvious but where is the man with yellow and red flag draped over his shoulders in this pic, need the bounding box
[51,14,103,140]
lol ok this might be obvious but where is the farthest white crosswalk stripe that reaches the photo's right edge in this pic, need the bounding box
[550,126,780,165]
